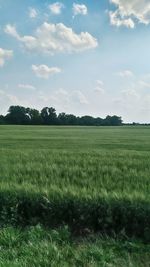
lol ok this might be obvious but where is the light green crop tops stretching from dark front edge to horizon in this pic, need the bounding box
[0,126,150,201]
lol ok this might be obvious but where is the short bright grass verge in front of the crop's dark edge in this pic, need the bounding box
[0,226,150,267]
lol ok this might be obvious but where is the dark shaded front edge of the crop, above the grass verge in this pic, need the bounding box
[0,192,150,241]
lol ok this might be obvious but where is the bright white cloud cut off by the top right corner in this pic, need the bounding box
[109,0,150,28]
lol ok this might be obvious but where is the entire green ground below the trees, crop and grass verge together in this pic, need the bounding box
[0,126,150,267]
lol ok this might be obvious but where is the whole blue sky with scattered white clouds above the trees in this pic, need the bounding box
[0,0,150,122]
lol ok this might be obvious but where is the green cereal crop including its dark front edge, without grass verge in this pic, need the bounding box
[0,126,150,241]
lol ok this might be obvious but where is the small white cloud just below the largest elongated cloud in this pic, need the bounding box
[32,65,61,79]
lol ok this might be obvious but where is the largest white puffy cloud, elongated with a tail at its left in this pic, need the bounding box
[4,22,98,55]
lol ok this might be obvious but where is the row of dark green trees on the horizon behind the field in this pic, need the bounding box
[0,106,122,126]
